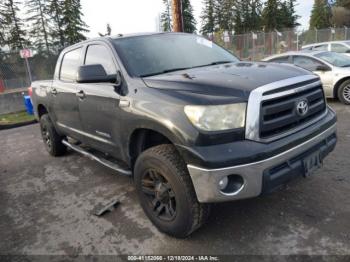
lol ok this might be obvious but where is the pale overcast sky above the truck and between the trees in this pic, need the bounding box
[81,0,314,37]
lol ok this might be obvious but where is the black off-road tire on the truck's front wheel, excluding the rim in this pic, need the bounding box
[134,144,210,238]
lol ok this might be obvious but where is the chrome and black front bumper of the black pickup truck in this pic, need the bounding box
[187,124,337,203]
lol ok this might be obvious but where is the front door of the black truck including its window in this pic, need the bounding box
[78,42,121,157]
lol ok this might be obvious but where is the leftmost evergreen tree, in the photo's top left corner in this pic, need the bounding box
[0,0,29,49]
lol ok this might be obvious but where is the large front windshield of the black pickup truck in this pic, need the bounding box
[113,34,239,77]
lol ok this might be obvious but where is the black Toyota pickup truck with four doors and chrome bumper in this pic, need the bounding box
[32,33,337,237]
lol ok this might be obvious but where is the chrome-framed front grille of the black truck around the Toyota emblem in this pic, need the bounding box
[246,75,327,142]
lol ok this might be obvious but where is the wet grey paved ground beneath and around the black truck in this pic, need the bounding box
[0,102,350,256]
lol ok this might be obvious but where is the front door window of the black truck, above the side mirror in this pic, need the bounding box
[85,45,117,75]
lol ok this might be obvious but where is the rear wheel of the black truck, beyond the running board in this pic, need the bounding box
[40,114,67,156]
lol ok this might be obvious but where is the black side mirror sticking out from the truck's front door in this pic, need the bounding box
[77,64,117,83]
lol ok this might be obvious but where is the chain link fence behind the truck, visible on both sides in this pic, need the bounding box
[0,27,350,93]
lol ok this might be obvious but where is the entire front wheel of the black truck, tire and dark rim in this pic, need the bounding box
[134,145,209,238]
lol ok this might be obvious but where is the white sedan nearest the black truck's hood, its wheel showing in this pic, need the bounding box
[263,51,350,105]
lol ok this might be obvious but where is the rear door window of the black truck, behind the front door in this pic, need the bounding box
[60,48,81,82]
